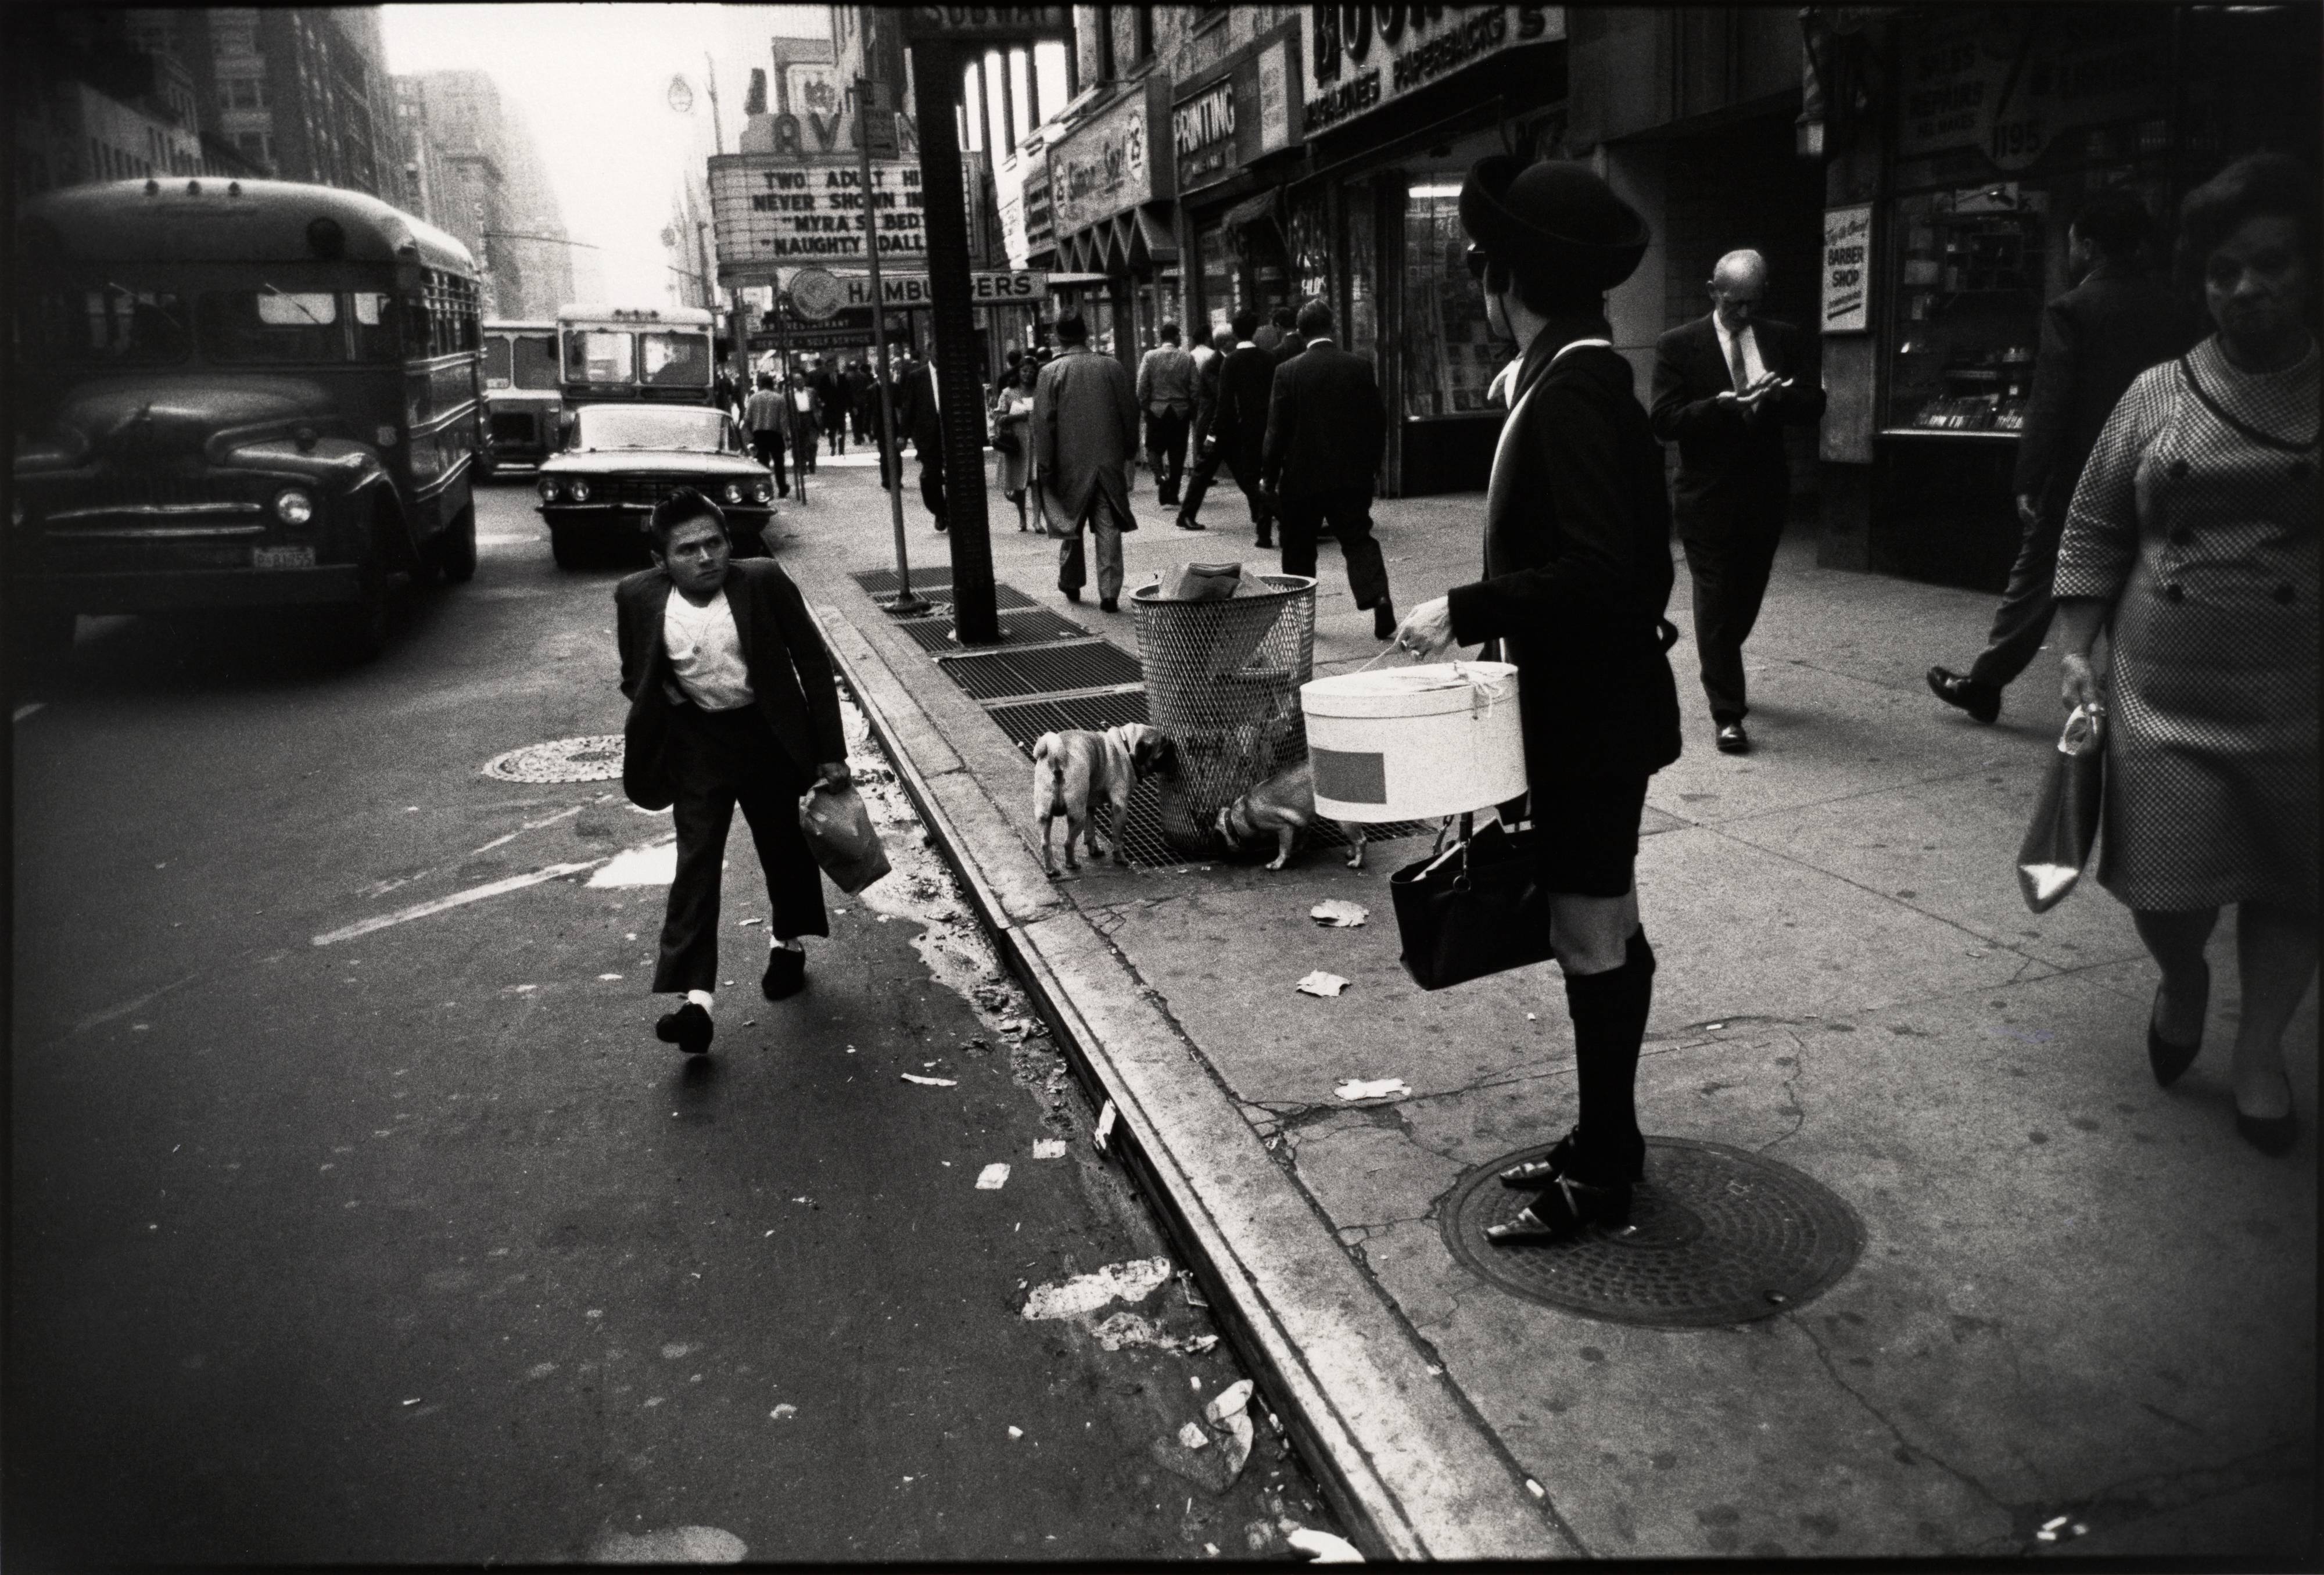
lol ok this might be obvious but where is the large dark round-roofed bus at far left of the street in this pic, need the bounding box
[9,179,479,660]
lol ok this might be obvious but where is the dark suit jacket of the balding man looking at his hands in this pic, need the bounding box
[1650,314,1824,537]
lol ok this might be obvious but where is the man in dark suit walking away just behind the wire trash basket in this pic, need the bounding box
[1260,300,1397,639]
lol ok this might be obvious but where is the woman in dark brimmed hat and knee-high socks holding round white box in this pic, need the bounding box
[1397,156,1678,1245]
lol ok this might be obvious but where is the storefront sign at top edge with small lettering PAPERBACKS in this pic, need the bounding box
[1306,5,1566,137]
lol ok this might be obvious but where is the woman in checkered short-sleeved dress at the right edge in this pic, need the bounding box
[2054,156,2319,1154]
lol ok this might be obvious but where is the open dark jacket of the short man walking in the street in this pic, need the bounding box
[614,558,848,808]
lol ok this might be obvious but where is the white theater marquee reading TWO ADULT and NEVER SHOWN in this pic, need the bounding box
[709,153,927,284]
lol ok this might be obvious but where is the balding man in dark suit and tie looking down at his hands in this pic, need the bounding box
[1652,251,1824,755]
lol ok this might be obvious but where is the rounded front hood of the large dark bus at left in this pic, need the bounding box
[16,374,346,469]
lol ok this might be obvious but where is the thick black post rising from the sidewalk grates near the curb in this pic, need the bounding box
[906,37,1002,646]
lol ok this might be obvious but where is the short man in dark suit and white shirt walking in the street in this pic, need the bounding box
[614,488,848,1054]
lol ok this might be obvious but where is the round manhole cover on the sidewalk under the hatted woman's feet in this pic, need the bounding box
[1443,1138,1864,1329]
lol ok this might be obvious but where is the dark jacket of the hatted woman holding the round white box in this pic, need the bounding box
[1450,330,1678,785]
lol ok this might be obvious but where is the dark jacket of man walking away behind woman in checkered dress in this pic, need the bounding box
[2013,263,2203,518]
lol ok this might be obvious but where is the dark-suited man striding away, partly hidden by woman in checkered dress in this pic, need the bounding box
[1929,191,2199,723]
